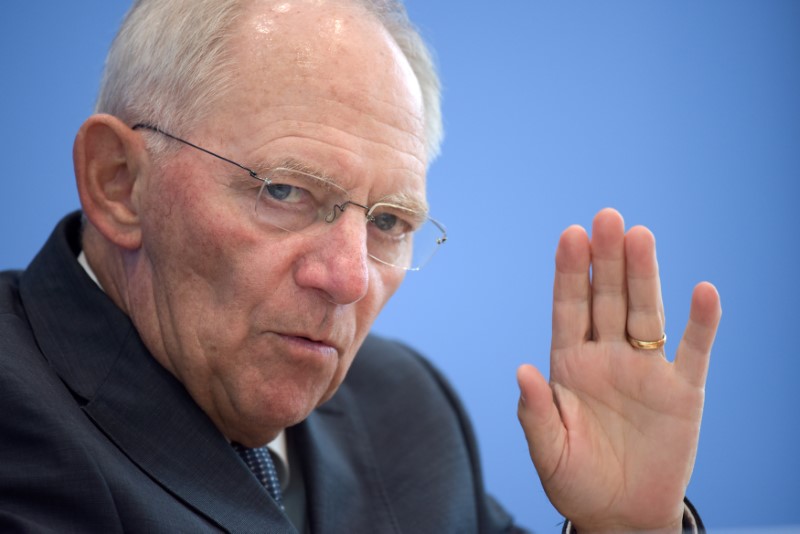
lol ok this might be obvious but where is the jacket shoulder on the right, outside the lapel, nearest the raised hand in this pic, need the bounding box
[336,335,513,532]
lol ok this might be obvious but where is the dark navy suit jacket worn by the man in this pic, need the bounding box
[0,214,513,533]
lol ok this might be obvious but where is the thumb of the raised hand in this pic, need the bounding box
[517,364,567,482]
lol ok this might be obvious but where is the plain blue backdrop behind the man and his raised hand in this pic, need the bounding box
[0,0,800,532]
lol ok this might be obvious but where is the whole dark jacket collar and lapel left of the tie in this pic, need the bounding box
[20,215,295,532]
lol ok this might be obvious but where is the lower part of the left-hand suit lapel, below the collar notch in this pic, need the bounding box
[85,328,294,532]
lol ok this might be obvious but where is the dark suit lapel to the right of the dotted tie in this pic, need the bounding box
[292,381,400,532]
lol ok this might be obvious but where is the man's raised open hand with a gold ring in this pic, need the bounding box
[518,209,721,533]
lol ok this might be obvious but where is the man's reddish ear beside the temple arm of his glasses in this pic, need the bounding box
[72,114,149,250]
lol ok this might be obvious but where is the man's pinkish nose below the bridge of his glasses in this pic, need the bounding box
[295,210,370,305]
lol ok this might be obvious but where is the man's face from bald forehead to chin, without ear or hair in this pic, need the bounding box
[130,0,426,445]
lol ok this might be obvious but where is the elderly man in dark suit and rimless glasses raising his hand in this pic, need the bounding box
[0,0,720,533]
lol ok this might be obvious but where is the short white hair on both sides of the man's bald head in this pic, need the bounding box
[95,0,444,163]
